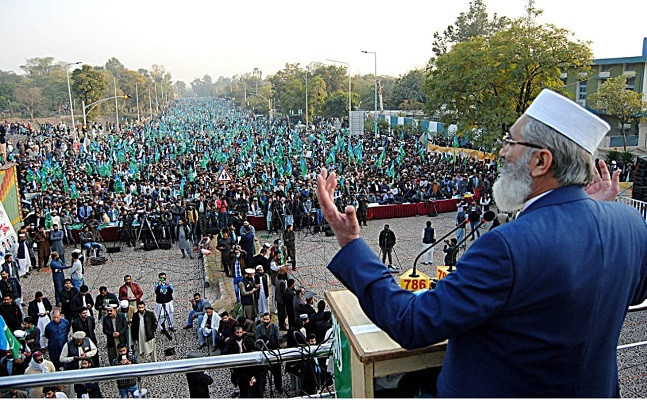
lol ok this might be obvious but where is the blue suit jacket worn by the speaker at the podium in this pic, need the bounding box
[328,186,647,397]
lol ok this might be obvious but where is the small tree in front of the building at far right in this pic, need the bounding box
[589,75,647,152]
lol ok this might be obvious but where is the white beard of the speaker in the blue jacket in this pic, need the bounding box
[492,152,532,212]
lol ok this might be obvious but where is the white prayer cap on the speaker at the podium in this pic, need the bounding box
[525,89,611,154]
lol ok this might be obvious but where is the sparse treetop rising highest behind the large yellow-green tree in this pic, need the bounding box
[432,0,511,56]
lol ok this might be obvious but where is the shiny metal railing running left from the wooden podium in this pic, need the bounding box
[0,344,332,389]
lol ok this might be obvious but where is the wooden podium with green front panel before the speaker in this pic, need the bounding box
[325,290,447,398]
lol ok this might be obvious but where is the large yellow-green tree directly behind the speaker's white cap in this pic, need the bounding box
[425,20,592,146]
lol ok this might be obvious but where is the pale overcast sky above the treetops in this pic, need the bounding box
[0,0,647,83]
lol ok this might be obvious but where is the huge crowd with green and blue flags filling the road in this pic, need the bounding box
[0,99,504,397]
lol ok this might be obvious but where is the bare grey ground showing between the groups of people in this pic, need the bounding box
[16,213,647,398]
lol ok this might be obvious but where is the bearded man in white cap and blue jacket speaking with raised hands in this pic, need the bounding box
[317,90,647,397]
